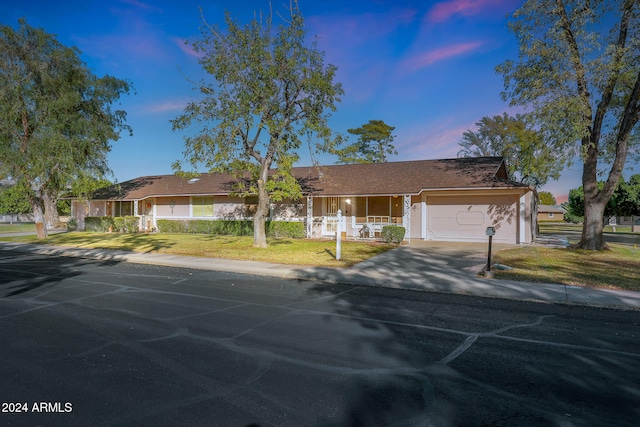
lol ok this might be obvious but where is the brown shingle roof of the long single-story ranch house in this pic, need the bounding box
[93,157,527,200]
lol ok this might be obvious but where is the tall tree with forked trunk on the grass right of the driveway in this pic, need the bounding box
[498,0,640,250]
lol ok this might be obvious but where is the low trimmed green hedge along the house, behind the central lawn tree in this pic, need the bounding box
[157,219,305,238]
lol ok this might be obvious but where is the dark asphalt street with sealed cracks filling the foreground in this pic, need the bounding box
[0,251,640,426]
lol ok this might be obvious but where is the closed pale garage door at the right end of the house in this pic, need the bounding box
[427,196,518,243]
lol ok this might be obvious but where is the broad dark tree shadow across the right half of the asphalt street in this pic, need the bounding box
[302,284,640,426]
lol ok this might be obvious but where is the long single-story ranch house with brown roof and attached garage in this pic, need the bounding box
[72,157,537,243]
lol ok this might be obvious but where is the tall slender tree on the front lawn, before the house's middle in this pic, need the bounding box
[172,3,343,247]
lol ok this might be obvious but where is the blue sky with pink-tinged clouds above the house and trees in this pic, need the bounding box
[0,0,628,202]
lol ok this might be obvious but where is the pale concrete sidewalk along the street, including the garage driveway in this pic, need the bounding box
[0,242,640,309]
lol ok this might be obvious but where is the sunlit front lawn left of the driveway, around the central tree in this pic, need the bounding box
[1,232,394,267]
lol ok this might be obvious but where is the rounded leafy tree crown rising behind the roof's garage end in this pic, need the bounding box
[458,113,563,188]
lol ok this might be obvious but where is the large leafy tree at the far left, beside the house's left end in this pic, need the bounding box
[0,20,130,238]
